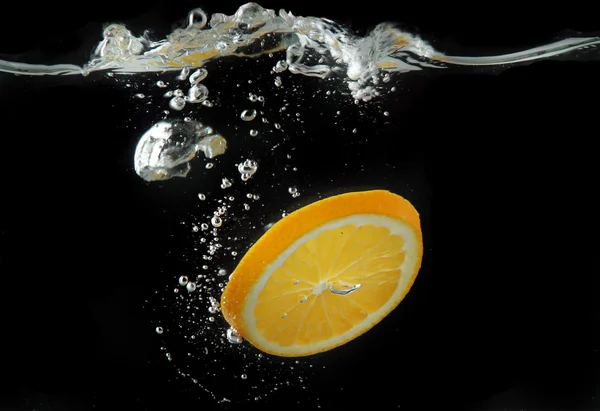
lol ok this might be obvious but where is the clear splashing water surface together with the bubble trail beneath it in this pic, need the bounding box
[0,4,600,410]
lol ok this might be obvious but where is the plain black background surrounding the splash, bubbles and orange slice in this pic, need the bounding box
[0,1,600,410]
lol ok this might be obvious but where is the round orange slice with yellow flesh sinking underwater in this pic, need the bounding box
[221,190,423,357]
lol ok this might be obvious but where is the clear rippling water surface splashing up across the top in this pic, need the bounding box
[0,3,600,101]
